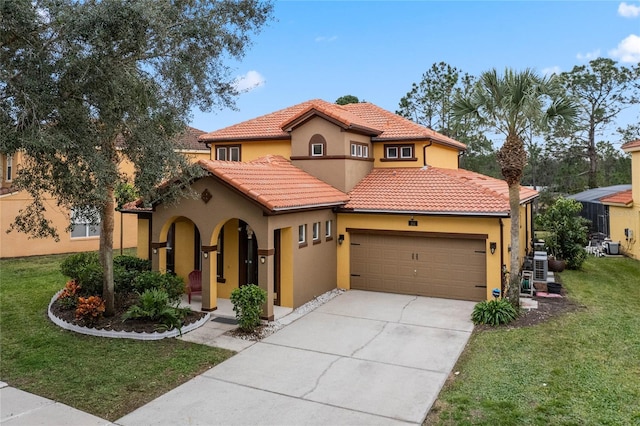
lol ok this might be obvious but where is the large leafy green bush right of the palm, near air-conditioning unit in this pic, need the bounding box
[536,197,589,269]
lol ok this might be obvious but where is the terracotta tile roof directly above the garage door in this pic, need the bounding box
[344,167,538,216]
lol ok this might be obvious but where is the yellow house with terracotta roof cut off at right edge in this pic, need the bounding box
[600,140,640,259]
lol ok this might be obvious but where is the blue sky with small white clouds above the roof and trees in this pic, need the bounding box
[191,0,640,146]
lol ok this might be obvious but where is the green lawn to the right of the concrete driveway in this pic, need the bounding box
[426,257,640,425]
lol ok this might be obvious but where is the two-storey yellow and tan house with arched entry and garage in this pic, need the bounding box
[128,100,537,318]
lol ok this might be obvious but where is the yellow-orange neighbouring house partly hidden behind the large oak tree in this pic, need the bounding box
[0,128,209,258]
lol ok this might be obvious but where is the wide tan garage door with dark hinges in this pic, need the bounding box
[350,233,487,301]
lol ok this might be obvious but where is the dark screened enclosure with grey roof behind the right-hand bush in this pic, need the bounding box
[567,185,631,237]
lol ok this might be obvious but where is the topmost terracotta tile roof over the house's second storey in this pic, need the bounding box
[200,99,466,149]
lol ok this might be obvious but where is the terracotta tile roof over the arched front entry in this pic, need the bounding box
[198,155,348,212]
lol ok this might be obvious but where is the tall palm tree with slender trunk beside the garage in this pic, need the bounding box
[453,69,577,306]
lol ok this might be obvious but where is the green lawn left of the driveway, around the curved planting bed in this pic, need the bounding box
[0,256,233,421]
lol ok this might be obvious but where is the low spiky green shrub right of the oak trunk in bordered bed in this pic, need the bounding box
[123,288,190,330]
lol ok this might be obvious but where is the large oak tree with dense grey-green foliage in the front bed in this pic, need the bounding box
[0,0,272,314]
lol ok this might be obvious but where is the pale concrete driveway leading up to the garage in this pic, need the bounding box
[116,290,475,426]
